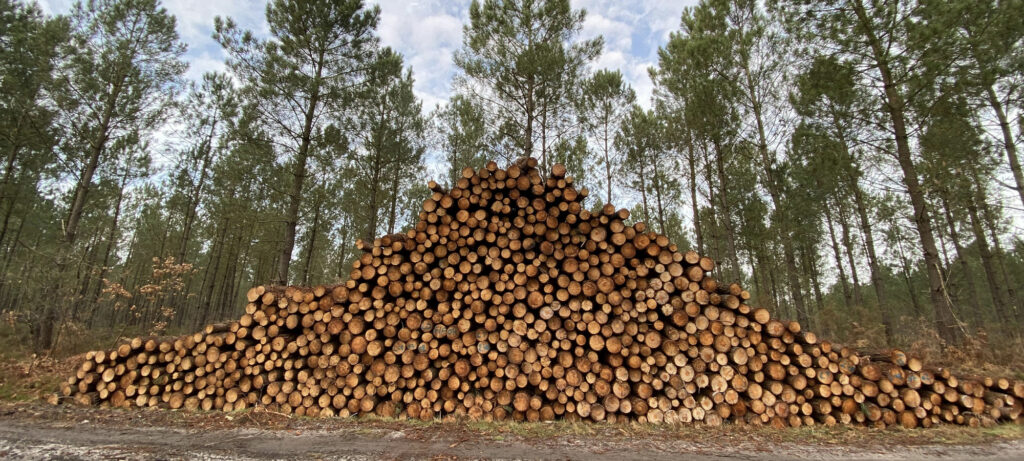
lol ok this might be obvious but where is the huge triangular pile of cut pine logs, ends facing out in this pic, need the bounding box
[61,159,1024,427]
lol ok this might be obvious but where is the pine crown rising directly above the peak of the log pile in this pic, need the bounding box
[455,0,603,166]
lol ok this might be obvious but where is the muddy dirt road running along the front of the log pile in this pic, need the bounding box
[0,405,1024,461]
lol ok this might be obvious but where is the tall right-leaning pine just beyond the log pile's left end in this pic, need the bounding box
[36,0,186,348]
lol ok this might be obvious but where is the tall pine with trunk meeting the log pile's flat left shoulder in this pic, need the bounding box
[214,0,380,284]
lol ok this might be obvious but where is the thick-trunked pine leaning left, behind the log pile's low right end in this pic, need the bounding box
[772,0,963,344]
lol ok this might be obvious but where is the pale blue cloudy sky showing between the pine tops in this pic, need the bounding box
[38,0,696,111]
